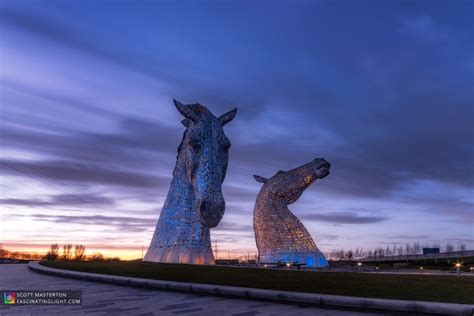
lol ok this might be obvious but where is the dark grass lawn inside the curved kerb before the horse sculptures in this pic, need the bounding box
[41,261,474,304]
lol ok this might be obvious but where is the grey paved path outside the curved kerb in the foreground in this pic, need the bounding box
[0,264,375,316]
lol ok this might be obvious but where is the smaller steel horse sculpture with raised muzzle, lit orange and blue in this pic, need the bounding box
[253,158,331,267]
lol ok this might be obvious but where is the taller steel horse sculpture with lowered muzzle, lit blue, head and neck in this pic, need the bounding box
[144,100,237,264]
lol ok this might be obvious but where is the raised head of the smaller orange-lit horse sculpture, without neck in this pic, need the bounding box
[254,158,331,204]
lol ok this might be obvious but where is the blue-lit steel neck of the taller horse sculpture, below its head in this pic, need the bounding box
[145,148,214,264]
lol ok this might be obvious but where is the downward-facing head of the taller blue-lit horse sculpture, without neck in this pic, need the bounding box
[173,100,237,228]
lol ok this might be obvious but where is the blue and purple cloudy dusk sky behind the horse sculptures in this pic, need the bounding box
[0,0,474,258]
